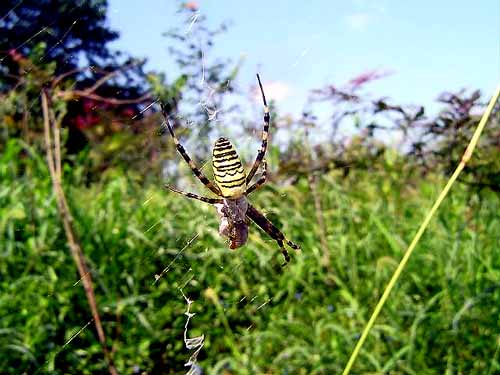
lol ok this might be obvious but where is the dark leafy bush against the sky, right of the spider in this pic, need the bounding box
[281,71,500,192]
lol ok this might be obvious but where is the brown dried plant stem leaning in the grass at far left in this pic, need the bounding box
[42,89,118,375]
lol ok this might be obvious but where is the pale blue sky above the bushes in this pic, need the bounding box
[109,0,500,117]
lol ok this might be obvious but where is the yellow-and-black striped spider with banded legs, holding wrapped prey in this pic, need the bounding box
[161,74,300,266]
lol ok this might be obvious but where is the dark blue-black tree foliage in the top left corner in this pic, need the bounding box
[0,0,118,91]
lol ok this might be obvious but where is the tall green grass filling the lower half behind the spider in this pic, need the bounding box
[0,141,500,374]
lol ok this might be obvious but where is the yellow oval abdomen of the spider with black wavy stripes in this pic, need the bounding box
[212,138,247,198]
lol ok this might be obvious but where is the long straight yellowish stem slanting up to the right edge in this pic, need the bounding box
[342,86,500,375]
